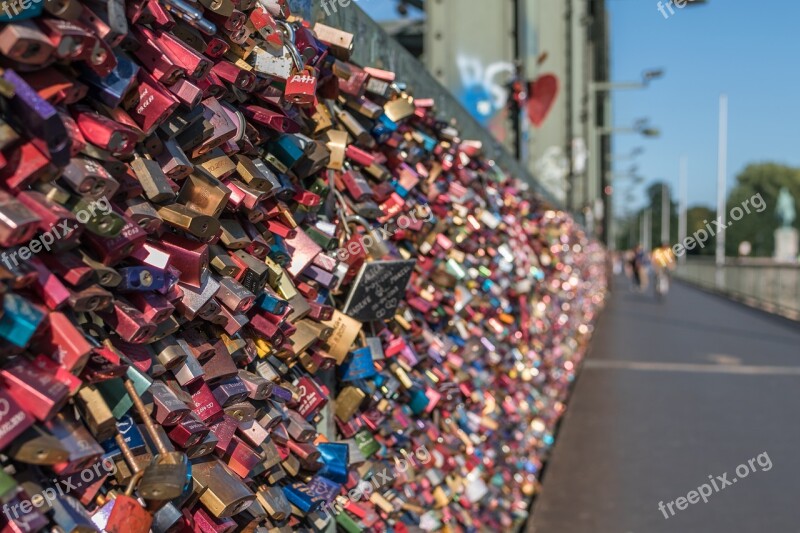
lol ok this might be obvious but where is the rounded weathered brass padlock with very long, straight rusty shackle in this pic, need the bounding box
[125,380,188,500]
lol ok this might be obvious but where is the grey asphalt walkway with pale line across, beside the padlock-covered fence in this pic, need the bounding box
[528,280,800,533]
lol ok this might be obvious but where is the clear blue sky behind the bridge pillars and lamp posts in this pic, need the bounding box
[358,0,800,210]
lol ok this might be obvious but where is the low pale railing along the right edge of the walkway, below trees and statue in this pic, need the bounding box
[676,258,800,320]
